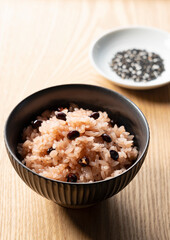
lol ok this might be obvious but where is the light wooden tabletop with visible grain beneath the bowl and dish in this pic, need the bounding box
[0,0,170,240]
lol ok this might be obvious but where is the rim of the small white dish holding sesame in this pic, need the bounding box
[89,25,170,90]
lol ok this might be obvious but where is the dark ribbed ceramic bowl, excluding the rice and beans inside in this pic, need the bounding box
[5,84,149,208]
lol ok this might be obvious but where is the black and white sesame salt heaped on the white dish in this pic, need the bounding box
[110,49,165,82]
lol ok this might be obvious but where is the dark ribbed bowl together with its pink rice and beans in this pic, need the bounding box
[4,84,150,208]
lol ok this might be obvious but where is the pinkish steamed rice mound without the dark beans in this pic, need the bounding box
[18,107,138,182]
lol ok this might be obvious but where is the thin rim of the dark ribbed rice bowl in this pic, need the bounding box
[4,83,150,185]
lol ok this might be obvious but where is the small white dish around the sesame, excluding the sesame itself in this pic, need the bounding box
[90,26,170,90]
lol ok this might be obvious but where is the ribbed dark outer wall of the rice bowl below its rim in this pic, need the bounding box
[7,142,147,208]
